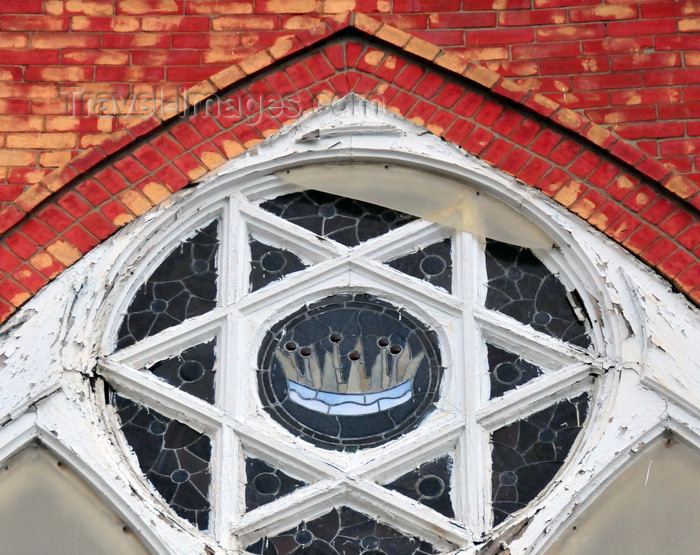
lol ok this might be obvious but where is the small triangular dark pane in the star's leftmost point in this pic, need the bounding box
[148,339,216,403]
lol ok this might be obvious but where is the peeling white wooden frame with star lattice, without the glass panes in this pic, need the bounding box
[0,97,700,553]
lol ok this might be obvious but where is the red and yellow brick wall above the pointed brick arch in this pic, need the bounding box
[0,0,700,322]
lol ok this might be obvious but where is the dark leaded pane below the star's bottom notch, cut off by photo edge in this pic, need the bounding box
[246,507,438,555]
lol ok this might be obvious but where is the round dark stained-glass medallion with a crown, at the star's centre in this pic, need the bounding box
[258,294,442,449]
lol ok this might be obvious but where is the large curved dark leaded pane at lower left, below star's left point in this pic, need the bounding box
[112,393,211,530]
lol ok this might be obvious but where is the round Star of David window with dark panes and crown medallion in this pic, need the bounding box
[100,176,597,555]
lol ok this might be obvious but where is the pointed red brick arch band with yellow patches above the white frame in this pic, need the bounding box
[0,12,700,321]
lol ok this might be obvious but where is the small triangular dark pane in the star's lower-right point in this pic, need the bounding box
[384,455,455,518]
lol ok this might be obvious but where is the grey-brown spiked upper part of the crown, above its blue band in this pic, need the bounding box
[275,333,425,395]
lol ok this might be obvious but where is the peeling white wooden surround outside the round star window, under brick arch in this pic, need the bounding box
[0,101,700,554]
